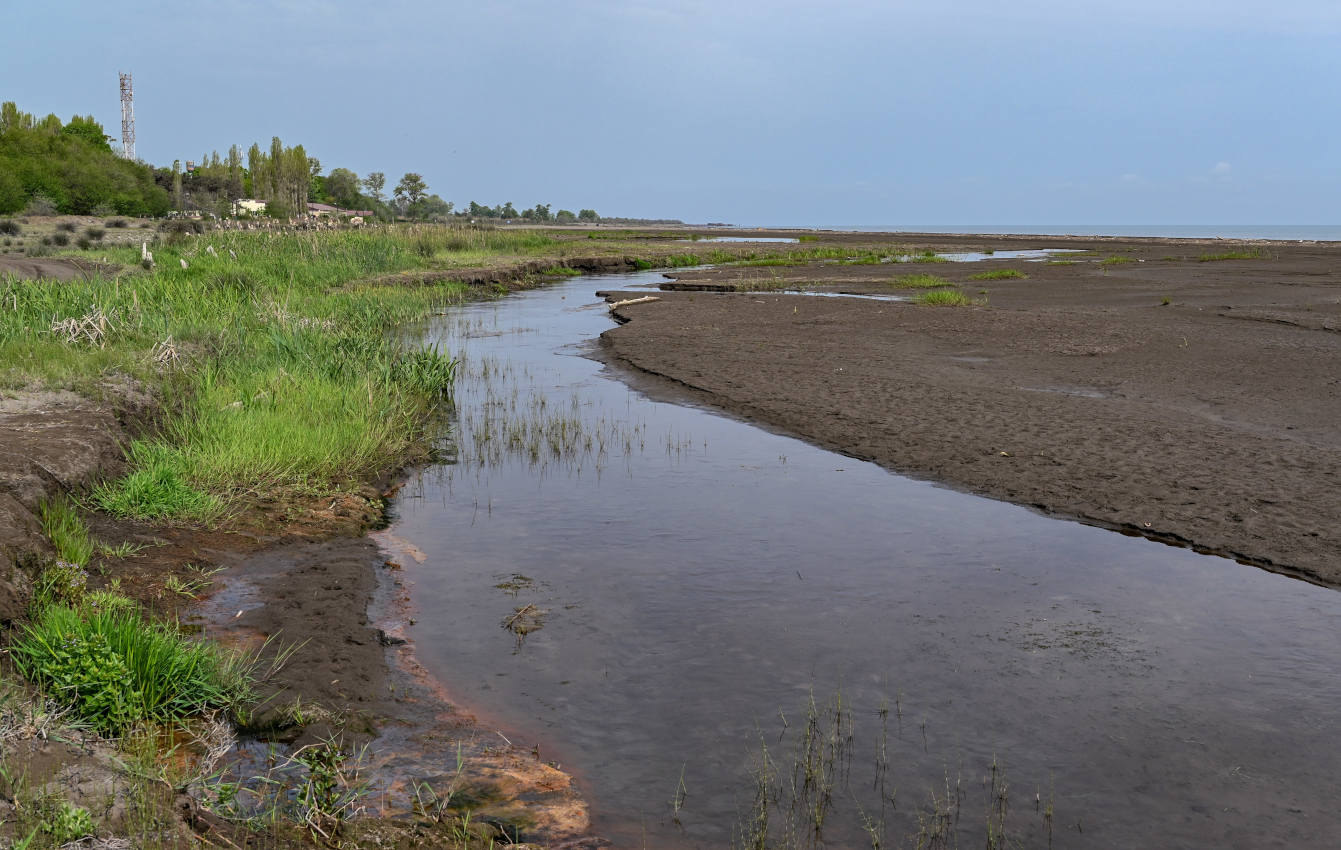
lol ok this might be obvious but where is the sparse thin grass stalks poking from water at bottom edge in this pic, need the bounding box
[729,692,1054,850]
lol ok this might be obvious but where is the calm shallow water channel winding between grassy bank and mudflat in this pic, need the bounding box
[390,272,1341,847]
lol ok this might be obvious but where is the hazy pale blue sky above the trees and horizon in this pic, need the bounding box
[0,0,1341,227]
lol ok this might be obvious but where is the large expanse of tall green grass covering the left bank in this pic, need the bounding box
[0,228,488,522]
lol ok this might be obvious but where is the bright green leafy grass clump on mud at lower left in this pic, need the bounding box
[9,605,251,735]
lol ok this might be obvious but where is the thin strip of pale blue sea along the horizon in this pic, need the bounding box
[788,224,1341,241]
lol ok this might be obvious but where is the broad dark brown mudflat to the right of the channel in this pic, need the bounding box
[602,235,1341,585]
